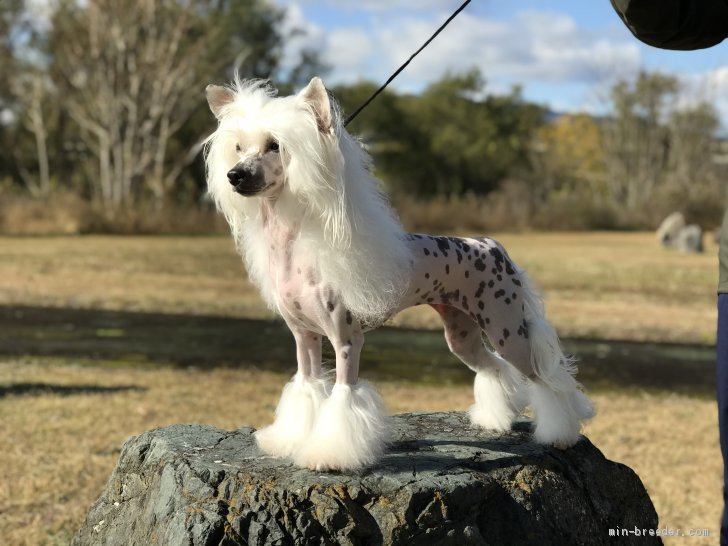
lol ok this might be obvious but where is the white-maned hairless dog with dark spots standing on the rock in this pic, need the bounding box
[205,78,594,471]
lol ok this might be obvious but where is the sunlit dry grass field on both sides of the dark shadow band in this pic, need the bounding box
[0,233,722,545]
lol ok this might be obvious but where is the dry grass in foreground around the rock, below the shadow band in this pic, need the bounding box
[0,360,721,546]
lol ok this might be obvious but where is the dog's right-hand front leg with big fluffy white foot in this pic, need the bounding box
[294,311,388,470]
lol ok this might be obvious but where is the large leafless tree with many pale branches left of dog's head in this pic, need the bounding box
[49,0,280,207]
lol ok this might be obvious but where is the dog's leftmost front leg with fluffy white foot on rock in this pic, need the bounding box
[255,330,329,457]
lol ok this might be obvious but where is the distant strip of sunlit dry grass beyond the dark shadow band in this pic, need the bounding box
[0,233,718,343]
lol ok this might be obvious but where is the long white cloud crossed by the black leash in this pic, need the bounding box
[280,7,641,93]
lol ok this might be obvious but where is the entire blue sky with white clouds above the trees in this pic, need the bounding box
[276,0,728,122]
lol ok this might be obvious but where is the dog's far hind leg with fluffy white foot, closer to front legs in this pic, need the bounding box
[432,304,526,431]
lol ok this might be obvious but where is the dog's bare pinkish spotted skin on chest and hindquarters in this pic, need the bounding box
[262,201,533,383]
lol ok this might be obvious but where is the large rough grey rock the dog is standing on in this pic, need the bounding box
[73,413,661,546]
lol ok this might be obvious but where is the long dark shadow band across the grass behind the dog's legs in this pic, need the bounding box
[0,306,715,397]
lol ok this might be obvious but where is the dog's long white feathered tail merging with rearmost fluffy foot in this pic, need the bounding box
[519,270,596,446]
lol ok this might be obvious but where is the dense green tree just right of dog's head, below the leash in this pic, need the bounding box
[337,71,543,197]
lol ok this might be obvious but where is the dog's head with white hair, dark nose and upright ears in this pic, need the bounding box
[206,78,334,199]
